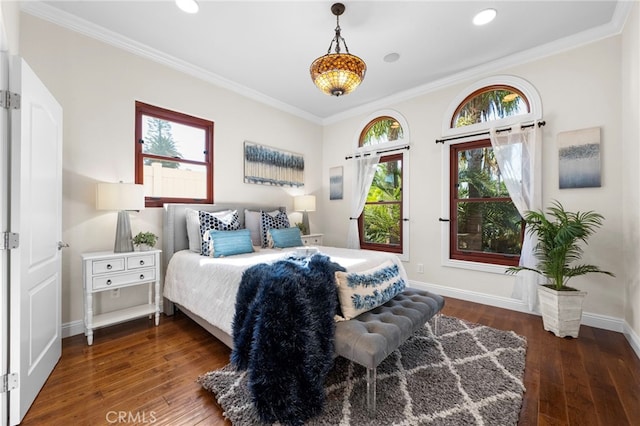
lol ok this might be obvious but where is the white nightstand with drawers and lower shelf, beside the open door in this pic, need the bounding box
[82,250,162,345]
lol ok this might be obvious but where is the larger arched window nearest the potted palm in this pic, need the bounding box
[443,76,542,266]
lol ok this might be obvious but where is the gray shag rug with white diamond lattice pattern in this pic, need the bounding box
[198,315,527,426]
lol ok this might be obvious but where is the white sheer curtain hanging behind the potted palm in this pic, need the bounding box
[489,125,542,311]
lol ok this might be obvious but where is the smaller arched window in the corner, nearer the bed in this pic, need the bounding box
[358,111,409,257]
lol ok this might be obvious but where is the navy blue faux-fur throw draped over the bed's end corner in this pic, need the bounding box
[231,254,345,425]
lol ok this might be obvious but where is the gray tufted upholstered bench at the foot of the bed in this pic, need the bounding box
[334,288,444,414]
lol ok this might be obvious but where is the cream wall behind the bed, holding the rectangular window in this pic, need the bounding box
[20,14,322,323]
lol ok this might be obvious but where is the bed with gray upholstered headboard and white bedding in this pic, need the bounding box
[162,203,408,348]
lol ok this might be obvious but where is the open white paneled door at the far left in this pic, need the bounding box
[9,57,62,425]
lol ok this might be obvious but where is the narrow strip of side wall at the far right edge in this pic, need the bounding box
[622,3,640,344]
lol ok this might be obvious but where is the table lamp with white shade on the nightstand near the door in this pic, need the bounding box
[96,183,144,253]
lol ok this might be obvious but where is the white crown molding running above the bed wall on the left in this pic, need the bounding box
[20,1,322,125]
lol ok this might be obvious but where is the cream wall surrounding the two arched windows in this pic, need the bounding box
[321,37,624,318]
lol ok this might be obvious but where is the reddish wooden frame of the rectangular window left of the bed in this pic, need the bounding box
[134,101,214,207]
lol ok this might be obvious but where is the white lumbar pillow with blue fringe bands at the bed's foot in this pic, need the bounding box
[336,260,407,320]
